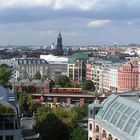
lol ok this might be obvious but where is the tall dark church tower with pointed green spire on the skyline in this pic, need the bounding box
[56,32,63,55]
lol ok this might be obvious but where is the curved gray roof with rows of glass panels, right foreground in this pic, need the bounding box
[95,95,140,140]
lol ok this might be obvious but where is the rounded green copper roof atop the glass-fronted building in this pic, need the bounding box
[68,53,89,63]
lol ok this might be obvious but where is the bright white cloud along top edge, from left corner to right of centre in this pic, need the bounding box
[0,0,96,10]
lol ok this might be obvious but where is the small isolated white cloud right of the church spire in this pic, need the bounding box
[87,19,111,28]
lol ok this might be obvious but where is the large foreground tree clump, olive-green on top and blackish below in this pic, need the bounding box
[34,107,77,140]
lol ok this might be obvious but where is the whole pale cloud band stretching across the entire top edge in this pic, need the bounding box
[0,0,140,11]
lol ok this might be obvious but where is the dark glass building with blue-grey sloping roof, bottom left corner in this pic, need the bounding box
[0,86,23,140]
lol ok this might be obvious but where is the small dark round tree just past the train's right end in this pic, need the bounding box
[83,80,95,91]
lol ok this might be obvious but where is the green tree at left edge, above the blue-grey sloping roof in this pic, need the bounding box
[0,66,12,88]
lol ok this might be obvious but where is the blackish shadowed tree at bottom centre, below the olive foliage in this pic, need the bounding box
[34,113,69,140]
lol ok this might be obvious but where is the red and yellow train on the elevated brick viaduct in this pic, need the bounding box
[51,88,83,93]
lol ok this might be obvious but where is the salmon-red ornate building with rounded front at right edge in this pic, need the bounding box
[118,61,139,92]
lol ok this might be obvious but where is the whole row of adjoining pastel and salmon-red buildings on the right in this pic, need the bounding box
[86,61,140,93]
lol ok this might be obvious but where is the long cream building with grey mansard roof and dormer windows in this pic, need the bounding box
[15,58,48,79]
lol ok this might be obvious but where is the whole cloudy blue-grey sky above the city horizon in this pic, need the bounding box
[0,0,140,46]
